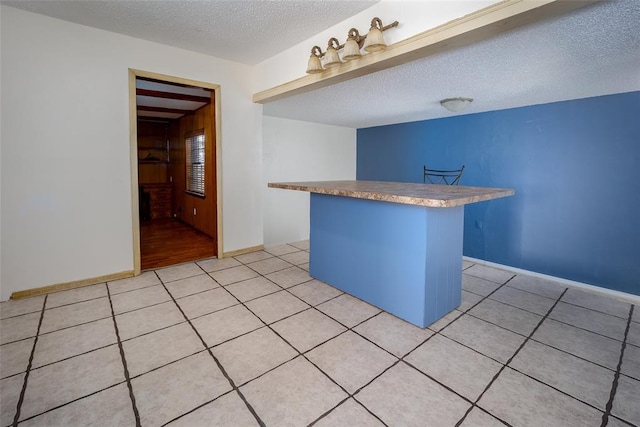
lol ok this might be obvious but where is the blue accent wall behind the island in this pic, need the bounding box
[356,92,640,295]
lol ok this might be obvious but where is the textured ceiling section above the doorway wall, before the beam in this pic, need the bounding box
[2,0,379,65]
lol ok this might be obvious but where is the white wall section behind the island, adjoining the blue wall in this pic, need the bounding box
[262,117,356,247]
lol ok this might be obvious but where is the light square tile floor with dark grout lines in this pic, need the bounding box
[0,241,640,427]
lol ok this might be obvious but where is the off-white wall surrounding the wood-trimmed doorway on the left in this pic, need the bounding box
[0,5,263,300]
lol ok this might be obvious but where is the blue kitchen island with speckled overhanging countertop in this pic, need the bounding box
[268,181,515,327]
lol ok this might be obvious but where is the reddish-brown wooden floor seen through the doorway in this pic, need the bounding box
[140,219,215,270]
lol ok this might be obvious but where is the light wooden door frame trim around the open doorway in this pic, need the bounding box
[129,68,223,276]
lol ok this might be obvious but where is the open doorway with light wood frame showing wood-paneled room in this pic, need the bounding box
[129,70,222,274]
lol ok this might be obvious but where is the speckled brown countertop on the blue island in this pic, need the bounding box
[268,181,515,208]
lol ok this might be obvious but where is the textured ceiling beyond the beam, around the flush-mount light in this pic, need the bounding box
[264,0,640,128]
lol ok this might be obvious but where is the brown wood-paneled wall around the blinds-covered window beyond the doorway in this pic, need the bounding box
[169,100,217,241]
